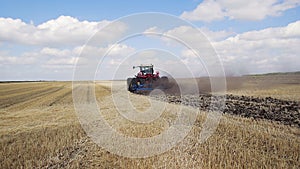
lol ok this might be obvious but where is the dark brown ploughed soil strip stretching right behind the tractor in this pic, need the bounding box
[152,94,300,127]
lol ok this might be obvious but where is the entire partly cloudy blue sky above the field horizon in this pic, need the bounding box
[0,0,300,81]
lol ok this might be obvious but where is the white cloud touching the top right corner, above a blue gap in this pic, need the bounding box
[181,0,300,22]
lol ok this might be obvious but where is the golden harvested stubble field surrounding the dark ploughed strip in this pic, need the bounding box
[0,74,300,168]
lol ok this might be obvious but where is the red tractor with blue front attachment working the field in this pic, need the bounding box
[127,64,169,93]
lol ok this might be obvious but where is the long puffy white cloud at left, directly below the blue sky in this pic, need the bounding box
[0,16,126,47]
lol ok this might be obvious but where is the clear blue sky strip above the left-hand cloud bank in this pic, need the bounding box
[0,0,198,24]
